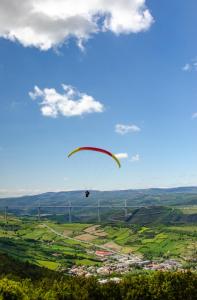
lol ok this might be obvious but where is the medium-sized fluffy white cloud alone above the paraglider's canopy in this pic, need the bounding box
[29,84,104,117]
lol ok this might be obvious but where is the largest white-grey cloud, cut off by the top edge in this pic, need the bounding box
[0,0,153,50]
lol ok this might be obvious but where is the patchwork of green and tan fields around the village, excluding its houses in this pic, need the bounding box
[0,217,197,270]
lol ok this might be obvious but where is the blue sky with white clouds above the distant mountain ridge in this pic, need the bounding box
[0,0,197,197]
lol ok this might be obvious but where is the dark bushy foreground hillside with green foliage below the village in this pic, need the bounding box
[0,255,197,300]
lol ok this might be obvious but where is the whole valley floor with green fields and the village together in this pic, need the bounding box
[0,216,197,276]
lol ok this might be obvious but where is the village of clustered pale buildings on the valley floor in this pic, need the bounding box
[68,250,181,281]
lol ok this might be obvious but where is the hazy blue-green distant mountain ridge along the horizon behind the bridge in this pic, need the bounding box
[0,186,197,207]
